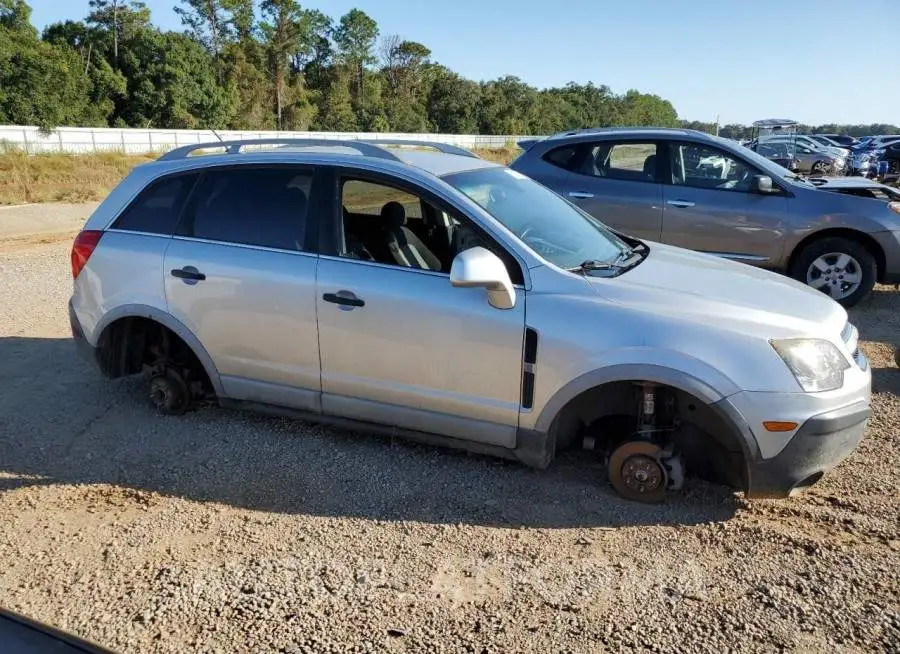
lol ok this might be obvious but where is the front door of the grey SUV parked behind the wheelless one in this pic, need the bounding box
[662,141,789,267]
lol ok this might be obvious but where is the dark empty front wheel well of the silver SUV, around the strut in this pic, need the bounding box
[553,380,748,488]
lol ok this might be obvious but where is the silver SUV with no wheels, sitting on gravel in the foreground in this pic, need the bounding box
[70,141,870,501]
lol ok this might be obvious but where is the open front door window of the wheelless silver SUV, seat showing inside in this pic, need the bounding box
[341,179,522,283]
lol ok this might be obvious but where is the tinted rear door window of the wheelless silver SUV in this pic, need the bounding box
[178,167,312,251]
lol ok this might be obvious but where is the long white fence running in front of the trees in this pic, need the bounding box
[0,125,525,154]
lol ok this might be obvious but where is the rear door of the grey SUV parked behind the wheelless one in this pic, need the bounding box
[563,141,663,241]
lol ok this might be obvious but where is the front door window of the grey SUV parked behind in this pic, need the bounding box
[669,143,756,193]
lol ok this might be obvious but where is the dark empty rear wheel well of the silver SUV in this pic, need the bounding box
[97,316,210,388]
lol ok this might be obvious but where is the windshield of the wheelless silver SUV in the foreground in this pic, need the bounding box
[443,168,629,268]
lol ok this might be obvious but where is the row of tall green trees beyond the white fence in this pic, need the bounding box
[0,0,678,134]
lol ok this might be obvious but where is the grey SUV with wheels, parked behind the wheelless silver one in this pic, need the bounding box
[511,128,900,307]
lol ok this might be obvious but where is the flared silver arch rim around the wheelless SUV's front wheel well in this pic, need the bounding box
[534,347,740,433]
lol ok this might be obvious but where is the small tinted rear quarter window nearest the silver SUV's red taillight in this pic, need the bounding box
[113,173,199,236]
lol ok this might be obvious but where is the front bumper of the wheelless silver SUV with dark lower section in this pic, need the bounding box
[746,402,870,497]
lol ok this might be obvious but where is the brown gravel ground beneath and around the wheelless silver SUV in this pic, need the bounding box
[0,207,900,653]
